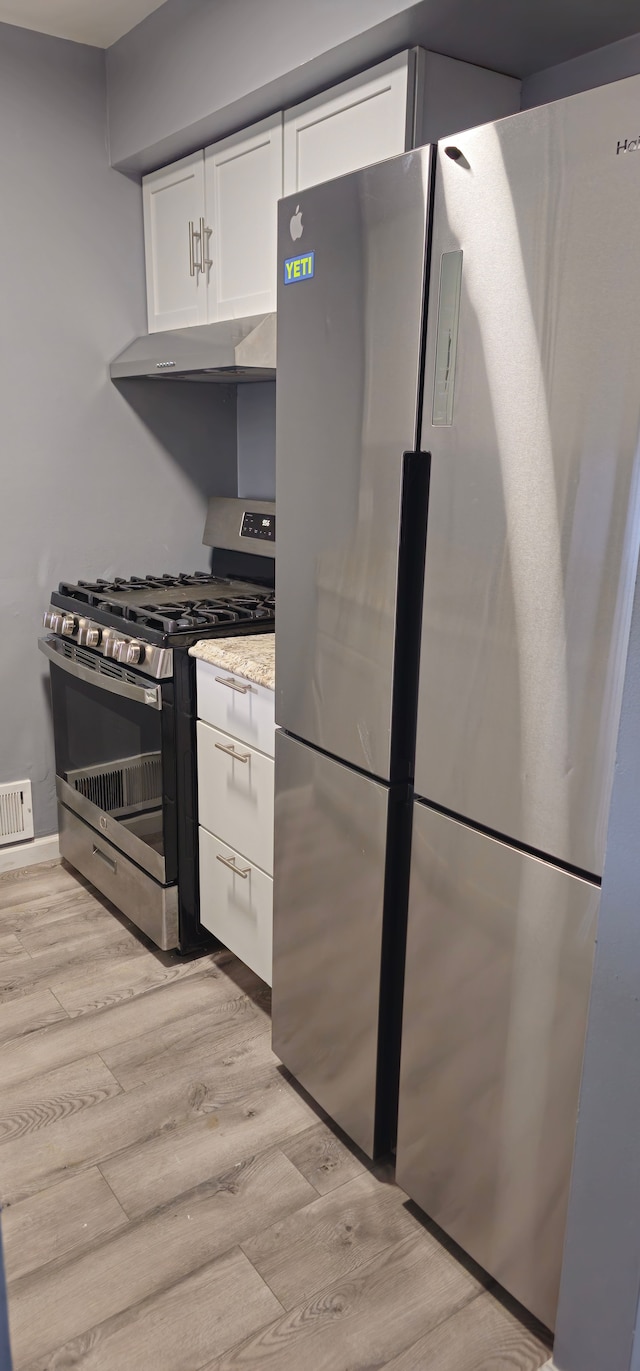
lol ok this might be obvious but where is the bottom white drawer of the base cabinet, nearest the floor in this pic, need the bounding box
[200,828,273,986]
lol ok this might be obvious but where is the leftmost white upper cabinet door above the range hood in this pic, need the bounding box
[143,152,207,333]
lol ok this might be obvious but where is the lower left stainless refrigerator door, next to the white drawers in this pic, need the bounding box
[273,731,389,1156]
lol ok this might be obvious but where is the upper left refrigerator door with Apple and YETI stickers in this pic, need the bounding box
[275,148,430,779]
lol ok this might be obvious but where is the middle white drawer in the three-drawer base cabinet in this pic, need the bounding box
[197,720,274,875]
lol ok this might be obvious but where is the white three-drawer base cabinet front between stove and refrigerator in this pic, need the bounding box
[196,661,275,984]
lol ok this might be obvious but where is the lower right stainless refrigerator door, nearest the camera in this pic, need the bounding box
[397,803,599,1327]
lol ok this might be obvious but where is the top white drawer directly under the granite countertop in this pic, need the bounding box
[196,662,275,757]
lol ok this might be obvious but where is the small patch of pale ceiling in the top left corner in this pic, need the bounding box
[0,0,164,48]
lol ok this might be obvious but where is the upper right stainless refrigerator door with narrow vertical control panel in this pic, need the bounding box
[415,77,640,875]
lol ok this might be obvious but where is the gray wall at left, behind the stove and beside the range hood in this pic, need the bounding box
[0,25,235,834]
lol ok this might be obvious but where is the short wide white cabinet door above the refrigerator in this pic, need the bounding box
[284,52,413,195]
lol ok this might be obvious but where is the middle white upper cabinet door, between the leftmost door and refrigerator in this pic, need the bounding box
[204,114,282,321]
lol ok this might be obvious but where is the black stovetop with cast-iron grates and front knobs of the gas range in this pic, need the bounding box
[44,572,275,680]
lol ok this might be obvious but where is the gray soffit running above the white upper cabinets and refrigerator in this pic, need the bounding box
[107,0,635,174]
